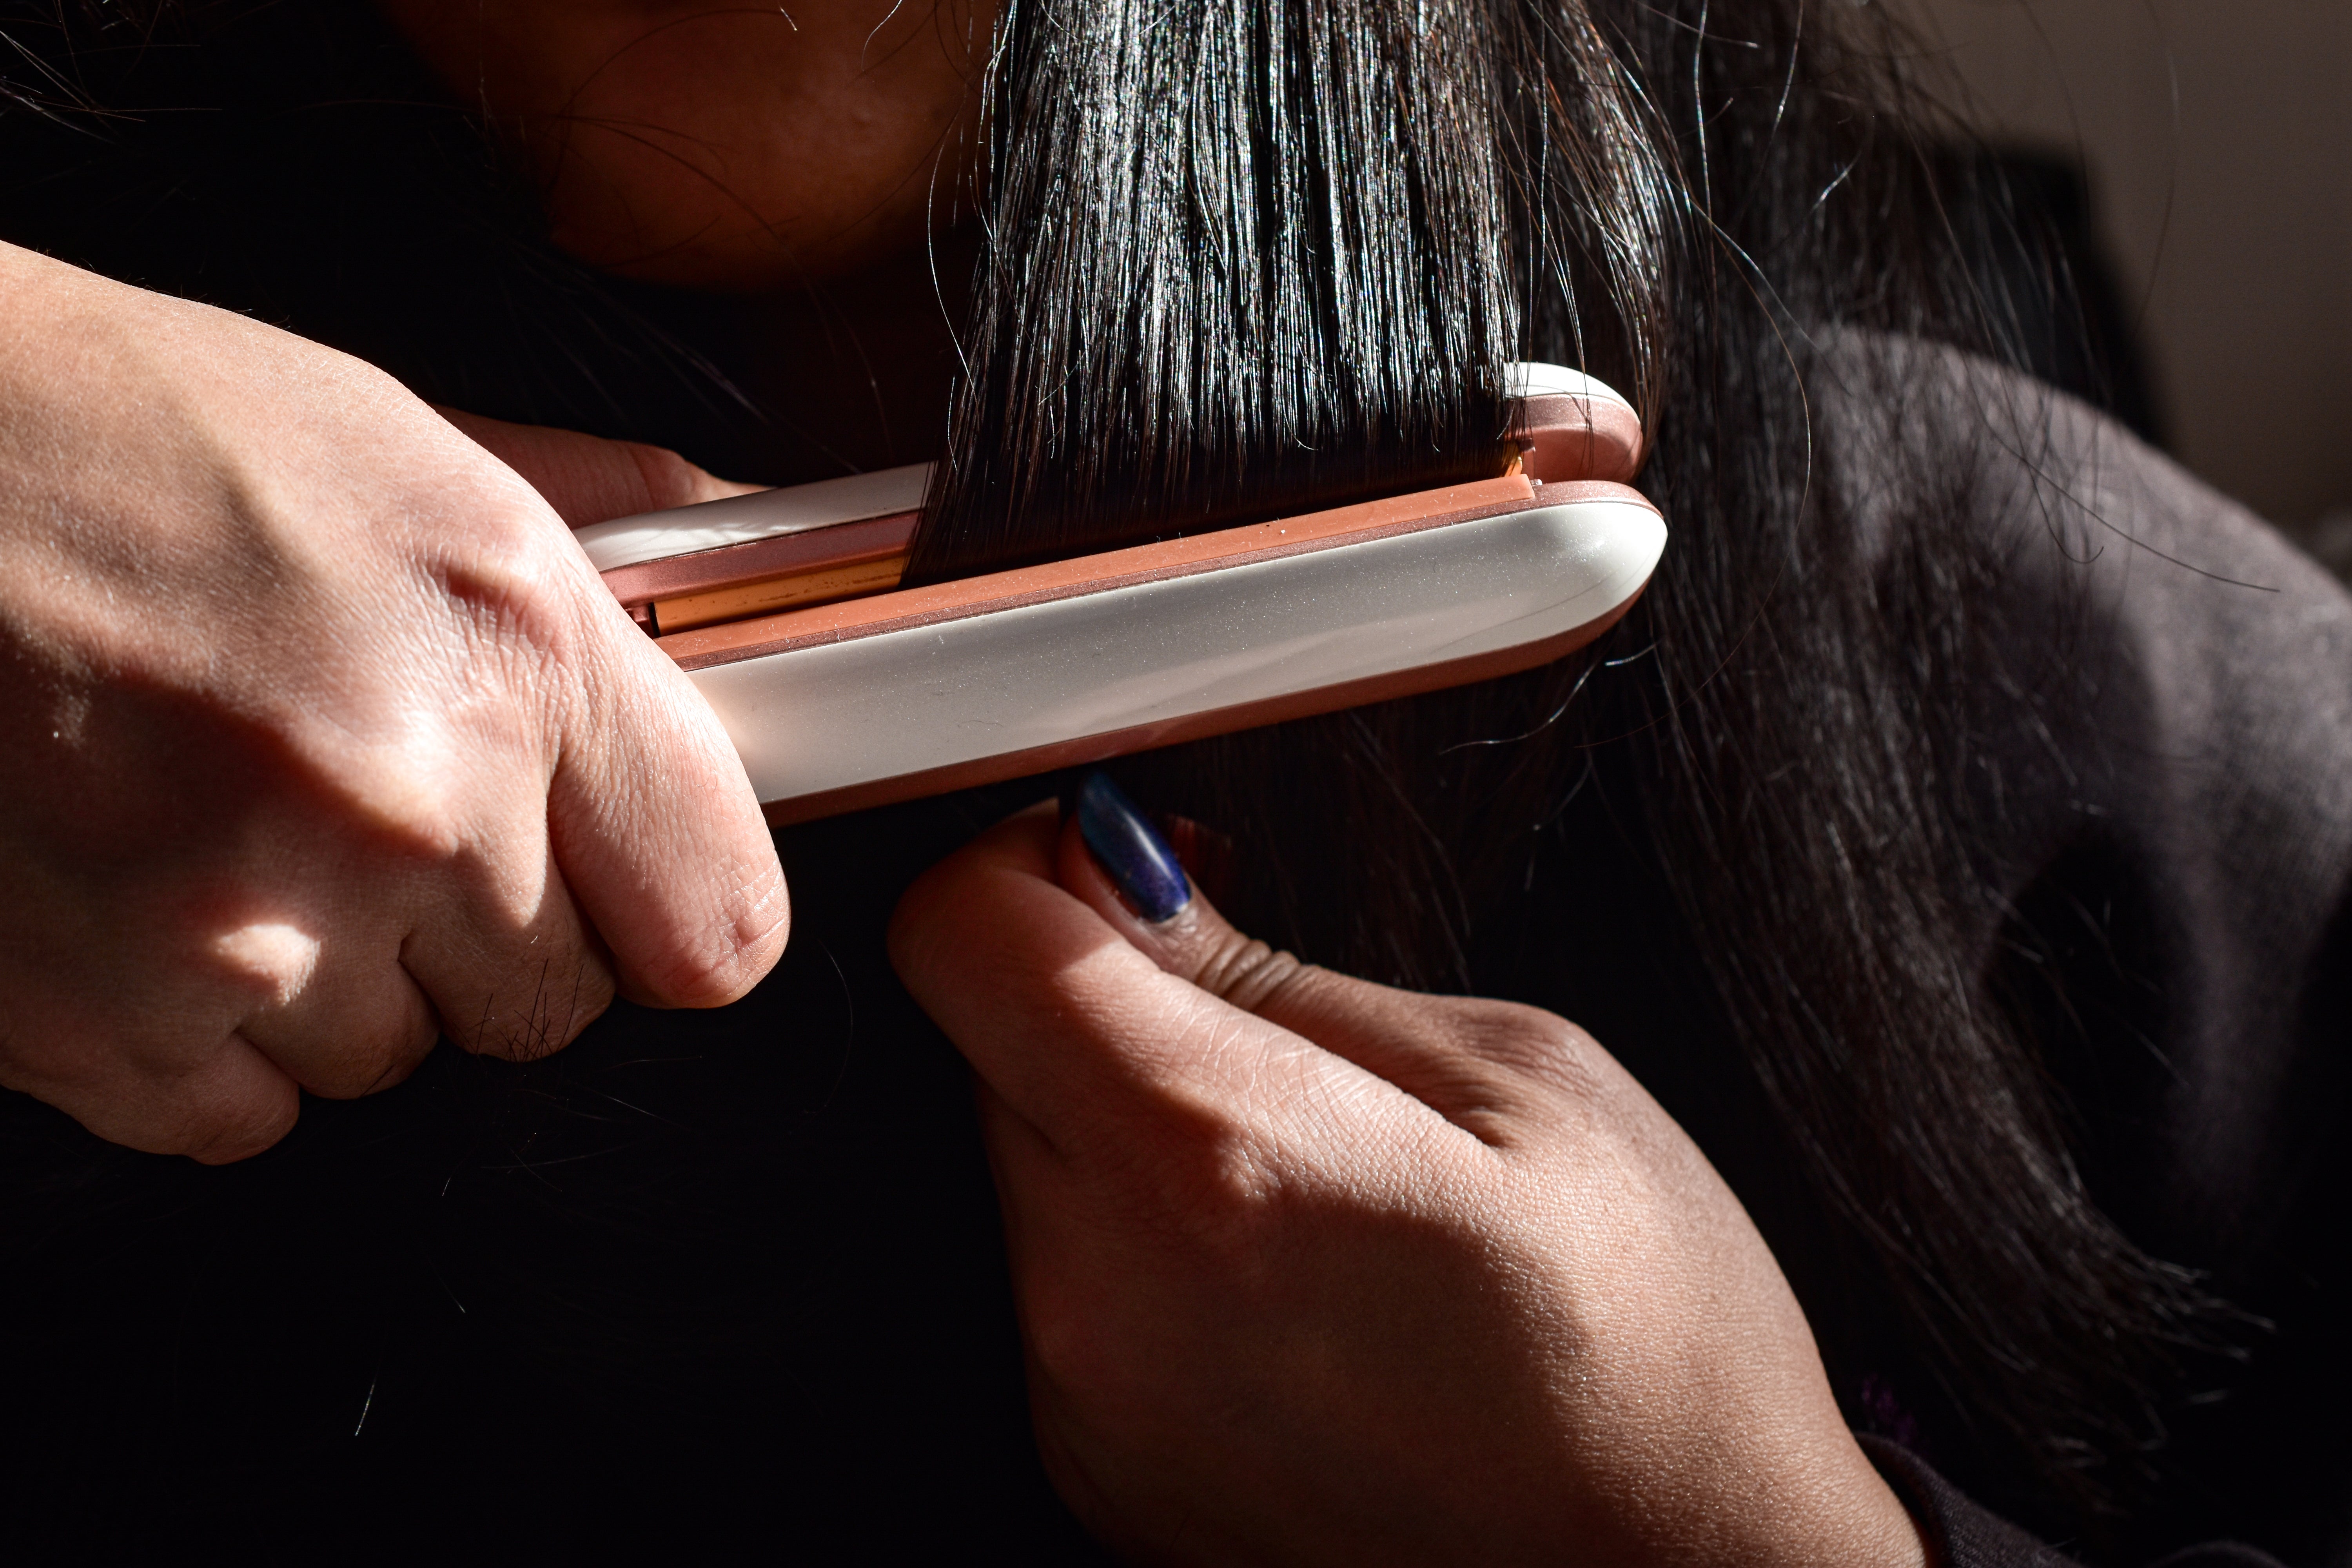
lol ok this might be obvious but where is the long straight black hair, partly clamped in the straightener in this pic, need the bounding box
[915,0,2209,1528]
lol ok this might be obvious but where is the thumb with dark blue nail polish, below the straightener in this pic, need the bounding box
[1054,771,1484,1114]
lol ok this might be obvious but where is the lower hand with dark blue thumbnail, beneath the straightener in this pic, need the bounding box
[891,776,1922,1566]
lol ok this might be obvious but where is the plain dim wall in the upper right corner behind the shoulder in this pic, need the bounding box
[1893,0,2352,571]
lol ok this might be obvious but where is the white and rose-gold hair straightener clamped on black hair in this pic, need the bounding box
[576,365,1665,823]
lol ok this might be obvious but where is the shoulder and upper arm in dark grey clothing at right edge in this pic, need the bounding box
[1806,334,2352,1559]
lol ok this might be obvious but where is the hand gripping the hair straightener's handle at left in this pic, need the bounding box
[0,247,786,1161]
